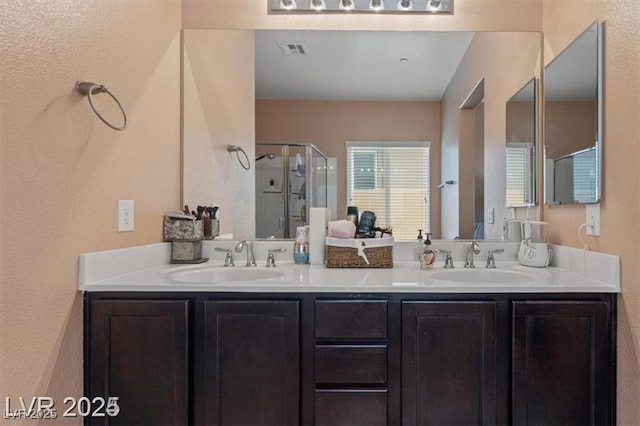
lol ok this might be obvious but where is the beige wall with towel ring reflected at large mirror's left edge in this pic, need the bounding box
[182,30,256,239]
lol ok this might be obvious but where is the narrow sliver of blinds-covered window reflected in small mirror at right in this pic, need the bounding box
[506,142,534,207]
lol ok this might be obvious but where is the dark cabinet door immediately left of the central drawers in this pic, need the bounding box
[201,301,300,426]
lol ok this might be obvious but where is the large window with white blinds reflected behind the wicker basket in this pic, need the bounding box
[347,142,431,239]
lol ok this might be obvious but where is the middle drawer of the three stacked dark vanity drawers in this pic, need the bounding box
[315,345,387,385]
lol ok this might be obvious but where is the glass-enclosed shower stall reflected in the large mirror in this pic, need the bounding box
[255,143,327,238]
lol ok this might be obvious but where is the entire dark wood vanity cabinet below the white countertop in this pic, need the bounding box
[85,292,616,426]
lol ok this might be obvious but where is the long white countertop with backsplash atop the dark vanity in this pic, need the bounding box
[79,240,620,293]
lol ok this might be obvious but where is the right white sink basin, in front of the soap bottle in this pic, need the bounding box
[431,268,537,284]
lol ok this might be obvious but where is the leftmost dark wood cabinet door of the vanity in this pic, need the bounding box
[86,300,189,425]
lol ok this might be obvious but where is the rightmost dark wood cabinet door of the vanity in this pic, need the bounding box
[513,301,613,426]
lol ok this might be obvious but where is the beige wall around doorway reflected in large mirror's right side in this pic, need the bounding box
[442,32,541,239]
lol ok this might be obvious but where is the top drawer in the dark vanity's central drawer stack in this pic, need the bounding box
[316,300,387,339]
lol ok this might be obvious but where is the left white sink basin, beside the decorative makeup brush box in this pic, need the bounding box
[169,266,283,284]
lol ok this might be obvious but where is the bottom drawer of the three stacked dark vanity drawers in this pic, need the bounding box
[314,389,387,426]
